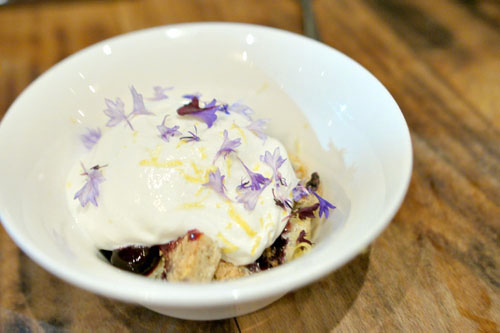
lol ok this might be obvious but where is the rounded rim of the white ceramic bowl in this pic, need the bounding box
[0,22,413,308]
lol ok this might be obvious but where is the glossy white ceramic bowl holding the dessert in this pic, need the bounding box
[0,23,412,320]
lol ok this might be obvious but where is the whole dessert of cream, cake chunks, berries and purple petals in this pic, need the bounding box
[66,86,335,282]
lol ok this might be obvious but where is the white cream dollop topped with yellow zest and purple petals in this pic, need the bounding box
[67,96,298,265]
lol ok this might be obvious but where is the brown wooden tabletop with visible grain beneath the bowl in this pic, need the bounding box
[0,0,500,332]
